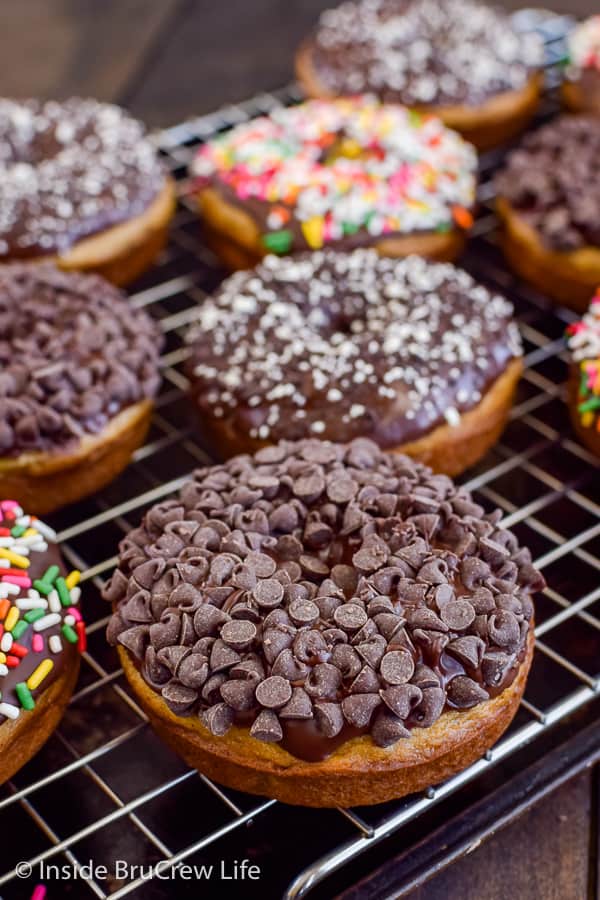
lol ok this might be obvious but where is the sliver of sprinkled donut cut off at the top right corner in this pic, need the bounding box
[561,15,600,116]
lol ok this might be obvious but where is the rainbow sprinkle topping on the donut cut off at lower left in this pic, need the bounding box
[0,500,85,722]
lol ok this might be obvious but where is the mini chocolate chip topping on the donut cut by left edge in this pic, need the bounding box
[0,263,162,457]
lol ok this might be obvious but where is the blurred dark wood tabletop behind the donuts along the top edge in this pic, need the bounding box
[0,0,597,125]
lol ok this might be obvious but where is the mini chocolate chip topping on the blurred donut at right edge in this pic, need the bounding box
[497,116,600,251]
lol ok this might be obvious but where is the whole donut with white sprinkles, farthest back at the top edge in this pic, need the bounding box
[296,0,544,149]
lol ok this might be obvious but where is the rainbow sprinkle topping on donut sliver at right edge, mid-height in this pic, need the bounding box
[567,288,600,432]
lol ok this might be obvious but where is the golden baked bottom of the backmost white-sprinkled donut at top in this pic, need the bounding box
[296,42,543,150]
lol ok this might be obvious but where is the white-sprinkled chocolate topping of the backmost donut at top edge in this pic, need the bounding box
[311,0,543,106]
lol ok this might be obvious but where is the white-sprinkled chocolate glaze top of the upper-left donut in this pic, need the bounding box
[0,97,165,259]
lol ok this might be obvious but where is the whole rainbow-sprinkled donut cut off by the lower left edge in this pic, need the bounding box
[0,500,86,784]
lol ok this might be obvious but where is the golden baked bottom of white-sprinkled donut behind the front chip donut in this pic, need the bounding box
[192,358,523,475]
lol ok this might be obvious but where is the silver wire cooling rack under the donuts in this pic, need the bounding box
[0,8,600,900]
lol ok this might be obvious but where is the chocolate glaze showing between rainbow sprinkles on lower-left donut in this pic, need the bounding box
[0,510,77,725]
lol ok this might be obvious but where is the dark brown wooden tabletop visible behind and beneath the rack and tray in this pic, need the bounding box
[0,0,600,900]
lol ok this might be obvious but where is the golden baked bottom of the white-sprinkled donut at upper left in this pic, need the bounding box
[3,178,176,285]
